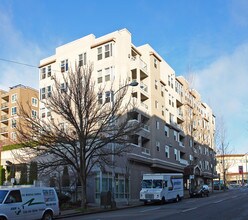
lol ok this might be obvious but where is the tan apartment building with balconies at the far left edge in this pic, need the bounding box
[0,85,39,146]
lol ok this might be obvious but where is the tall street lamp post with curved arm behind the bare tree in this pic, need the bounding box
[111,81,139,207]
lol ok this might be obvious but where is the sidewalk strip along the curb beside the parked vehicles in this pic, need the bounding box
[57,190,224,219]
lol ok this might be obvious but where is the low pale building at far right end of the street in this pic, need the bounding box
[216,154,248,185]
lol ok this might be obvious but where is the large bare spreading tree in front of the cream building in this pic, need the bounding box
[17,66,140,208]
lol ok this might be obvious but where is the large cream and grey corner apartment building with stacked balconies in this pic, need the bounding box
[40,29,215,203]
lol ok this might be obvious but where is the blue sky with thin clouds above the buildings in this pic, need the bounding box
[0,0,248,153]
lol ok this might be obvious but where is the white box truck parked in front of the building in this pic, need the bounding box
[140,173,184,204]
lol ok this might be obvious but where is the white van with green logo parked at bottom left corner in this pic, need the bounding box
[0,187,60,220]
